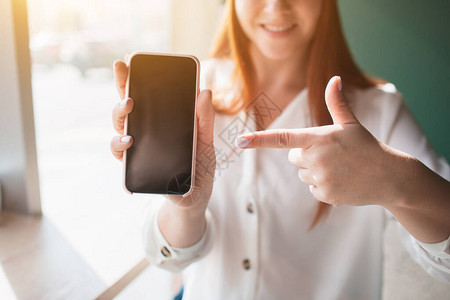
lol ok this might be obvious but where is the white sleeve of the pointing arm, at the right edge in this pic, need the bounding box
[388,97,450,283]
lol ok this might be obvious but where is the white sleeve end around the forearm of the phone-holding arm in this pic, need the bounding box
[143,201,214,272]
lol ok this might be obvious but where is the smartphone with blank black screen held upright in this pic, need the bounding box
[124,52,200,196]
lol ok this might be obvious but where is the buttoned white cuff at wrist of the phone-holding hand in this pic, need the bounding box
[152,203,212,263]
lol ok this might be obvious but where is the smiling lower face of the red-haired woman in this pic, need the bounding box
[235,0,323,60]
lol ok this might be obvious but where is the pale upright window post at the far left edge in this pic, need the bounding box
[0,0,40,213]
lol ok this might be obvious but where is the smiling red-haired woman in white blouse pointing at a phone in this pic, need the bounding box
[111,0,450,299]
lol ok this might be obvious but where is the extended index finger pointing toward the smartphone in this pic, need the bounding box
[235,128,317,148]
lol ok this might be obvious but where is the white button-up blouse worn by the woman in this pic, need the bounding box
[144,60,450,300]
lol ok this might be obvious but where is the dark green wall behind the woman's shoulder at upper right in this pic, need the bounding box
[338,0,450,161]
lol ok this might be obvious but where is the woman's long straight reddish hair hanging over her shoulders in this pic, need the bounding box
[211,0,376,229]
